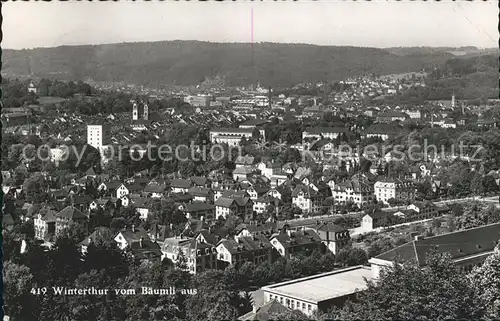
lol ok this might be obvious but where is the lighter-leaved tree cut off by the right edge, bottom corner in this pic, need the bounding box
[469,246,500,319]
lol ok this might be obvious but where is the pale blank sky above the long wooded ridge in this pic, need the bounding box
[2,0,499,49]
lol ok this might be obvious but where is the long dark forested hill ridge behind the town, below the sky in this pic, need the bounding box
[2,41,488,86]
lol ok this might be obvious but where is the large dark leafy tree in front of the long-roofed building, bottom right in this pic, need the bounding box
[332,253,483,320]
